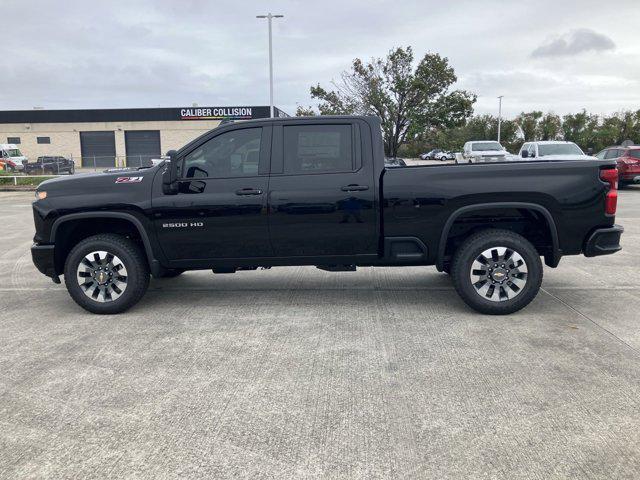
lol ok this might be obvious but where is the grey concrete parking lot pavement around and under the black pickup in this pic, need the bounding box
[0,186,640,479]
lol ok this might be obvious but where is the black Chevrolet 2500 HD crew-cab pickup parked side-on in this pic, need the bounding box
[31,117,623,314]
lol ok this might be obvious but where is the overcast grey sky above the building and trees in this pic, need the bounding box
[0,0,640,116]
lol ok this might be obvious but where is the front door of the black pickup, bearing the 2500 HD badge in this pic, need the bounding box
[153,126,272,261]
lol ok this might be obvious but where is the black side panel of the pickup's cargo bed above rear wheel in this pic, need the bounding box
[381,160,614,266]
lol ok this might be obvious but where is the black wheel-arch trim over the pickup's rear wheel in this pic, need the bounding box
[436,202,562,272]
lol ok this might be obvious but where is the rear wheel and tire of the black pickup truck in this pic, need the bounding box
[451,229,542,315]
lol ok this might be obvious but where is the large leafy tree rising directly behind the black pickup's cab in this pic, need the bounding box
[297,47,476,157]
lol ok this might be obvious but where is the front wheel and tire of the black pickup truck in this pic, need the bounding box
[64,234,149,314]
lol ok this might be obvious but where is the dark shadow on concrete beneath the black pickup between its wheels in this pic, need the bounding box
[138,268,542,319]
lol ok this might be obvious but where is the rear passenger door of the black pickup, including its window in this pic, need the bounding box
[269,120,378,261]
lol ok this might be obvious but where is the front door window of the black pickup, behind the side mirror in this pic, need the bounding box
[180,128,262,178]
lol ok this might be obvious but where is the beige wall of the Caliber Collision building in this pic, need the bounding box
[0,120,220,165]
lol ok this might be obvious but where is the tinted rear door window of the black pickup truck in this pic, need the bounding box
[284,125,355,174]
